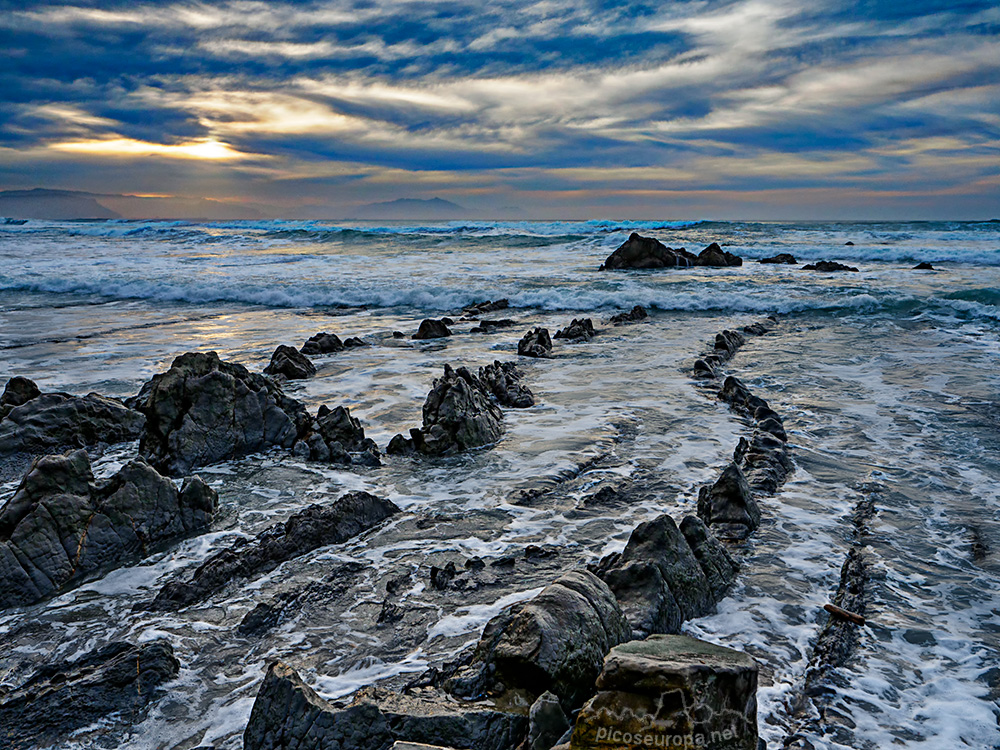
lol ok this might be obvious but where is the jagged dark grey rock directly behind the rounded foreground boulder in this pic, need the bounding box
[594,515,715,638]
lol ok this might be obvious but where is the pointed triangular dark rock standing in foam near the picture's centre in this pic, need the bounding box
[387,365,503,456]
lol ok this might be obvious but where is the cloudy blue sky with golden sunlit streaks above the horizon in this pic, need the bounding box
[0,0,1000,219]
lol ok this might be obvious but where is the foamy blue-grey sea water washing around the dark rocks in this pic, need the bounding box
[0,221,1000,750]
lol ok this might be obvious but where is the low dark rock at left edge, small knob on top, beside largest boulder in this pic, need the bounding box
[0,388,145,456]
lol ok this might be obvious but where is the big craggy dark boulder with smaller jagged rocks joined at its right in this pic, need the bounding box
[131,352,378,476]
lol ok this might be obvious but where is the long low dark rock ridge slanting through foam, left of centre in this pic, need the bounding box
[148,492,399,611]
